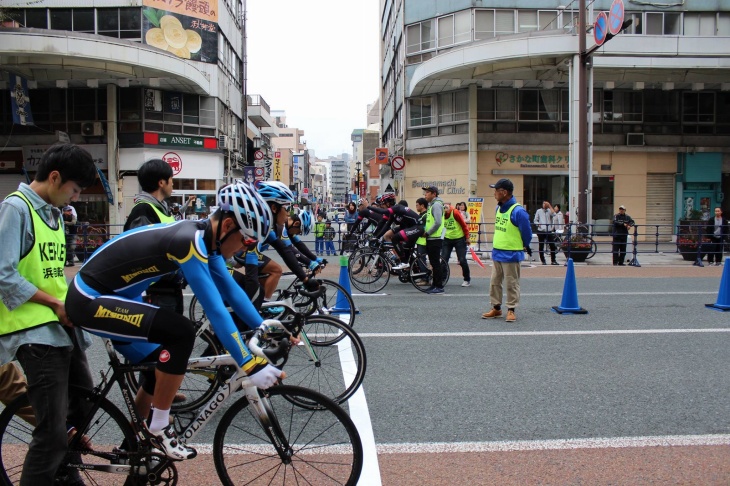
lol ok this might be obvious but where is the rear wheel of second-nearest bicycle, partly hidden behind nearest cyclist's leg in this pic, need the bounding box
[125,322,225,412]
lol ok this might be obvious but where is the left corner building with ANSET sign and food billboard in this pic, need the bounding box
[0,0,271,224]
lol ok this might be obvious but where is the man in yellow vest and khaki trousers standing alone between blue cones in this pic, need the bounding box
[482,179,532,322]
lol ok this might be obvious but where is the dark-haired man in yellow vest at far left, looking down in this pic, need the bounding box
[0,144,96,485]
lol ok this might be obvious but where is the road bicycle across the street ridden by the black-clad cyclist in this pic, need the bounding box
[347,242,451,293]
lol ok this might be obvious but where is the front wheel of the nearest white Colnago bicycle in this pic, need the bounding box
[213,385,363,486]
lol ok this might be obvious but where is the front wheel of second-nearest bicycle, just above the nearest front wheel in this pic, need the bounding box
[284,315,367,407]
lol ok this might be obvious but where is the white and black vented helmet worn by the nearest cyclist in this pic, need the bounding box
[217,180,274,241]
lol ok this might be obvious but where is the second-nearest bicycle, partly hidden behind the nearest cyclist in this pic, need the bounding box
[166,287,367,416]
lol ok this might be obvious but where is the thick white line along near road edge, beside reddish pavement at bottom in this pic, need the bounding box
[378,434,730,454]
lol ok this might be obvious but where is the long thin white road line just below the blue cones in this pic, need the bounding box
[357,328,730,338]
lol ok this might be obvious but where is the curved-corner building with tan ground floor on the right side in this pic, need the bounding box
[381,0,730,232]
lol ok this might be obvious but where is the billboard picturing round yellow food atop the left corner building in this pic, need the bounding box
[142,0,218,63]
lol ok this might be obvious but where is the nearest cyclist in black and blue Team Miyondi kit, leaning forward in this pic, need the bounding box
[66,182,281,460]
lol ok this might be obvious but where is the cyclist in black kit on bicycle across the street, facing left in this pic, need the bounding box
[371,193,424,270]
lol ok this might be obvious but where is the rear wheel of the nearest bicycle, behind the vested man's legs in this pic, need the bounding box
[0,387,142,485]
